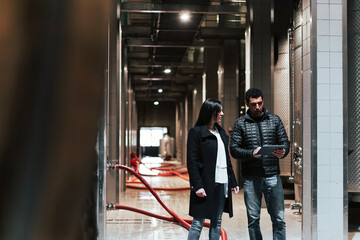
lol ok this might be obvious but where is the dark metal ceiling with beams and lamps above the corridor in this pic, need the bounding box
[120,0,246,101]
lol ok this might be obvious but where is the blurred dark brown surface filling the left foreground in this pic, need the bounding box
[0,0,109,240]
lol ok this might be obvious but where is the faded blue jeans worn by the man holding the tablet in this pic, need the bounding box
[243,175,286,240]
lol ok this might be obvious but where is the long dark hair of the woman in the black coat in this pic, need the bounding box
[195,99,221,126]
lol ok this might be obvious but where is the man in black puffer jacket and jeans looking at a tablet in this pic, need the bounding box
[230,88,290,240]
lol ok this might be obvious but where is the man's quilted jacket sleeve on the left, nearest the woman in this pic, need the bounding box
[230,119,254,161]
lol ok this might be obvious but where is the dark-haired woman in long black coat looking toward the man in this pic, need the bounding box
[187,99,239,240]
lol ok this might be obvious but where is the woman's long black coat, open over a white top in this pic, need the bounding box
[187,124,238,219]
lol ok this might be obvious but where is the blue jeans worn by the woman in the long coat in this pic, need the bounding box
[188,183,225,240]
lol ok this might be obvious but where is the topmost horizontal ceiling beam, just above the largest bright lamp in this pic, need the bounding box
[120,3,247,14]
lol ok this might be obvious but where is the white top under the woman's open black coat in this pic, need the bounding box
[210,128,228,183]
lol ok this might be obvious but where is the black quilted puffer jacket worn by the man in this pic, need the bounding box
[230,108,290,176]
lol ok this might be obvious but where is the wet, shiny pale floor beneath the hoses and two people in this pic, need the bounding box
[106,160,360,240]
